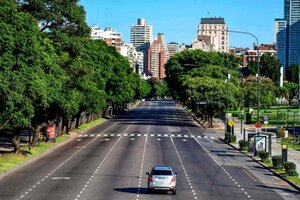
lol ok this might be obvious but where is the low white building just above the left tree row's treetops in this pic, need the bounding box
[91,25,123,53]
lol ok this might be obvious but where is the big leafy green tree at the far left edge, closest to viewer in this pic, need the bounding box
[0,0,64,153]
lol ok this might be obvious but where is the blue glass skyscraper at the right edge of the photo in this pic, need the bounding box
[275,0,300,70]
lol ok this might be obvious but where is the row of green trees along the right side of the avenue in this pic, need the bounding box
[166,50,299,127]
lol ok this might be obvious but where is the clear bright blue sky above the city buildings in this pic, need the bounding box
[80,0,283,48]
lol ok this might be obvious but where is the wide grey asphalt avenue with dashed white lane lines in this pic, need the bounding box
[0,101,300,200]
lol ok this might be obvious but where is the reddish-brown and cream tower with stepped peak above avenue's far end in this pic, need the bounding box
[148,33,169,79]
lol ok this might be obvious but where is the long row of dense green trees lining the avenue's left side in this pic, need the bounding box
[0,0,168,153]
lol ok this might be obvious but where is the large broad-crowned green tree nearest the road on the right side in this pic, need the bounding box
[166,50,241,126]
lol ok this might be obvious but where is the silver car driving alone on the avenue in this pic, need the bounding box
[146,166,177,195]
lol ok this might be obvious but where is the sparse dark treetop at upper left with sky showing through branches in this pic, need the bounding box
[17,0,90,36]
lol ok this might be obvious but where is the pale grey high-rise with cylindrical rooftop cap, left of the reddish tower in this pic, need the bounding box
[130,18,152,73]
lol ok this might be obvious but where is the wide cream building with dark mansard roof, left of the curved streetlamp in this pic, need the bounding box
[192,17,229,52]
